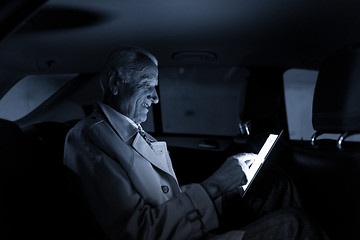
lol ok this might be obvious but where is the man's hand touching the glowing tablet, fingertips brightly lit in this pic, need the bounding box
[201,153,257,199]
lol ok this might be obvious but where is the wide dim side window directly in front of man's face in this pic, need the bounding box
[159,67,248,136]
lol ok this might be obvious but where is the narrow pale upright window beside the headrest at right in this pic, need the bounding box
[284,69,318,140]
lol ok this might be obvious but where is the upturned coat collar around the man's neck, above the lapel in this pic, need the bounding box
[98,102,138,142]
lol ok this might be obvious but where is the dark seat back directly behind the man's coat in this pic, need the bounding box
[23,121,105,240]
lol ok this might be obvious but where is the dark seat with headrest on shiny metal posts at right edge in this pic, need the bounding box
[292,53,360,239]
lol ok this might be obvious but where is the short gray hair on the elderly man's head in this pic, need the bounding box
[100,46,158,95]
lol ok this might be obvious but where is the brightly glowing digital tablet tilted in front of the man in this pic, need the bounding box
[241,131,283,196]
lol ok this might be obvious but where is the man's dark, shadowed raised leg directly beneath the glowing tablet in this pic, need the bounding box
[221,165,302,232]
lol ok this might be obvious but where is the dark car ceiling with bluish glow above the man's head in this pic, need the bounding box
[0,0,360,93]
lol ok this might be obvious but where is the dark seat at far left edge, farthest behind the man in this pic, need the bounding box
[0,119,30,239]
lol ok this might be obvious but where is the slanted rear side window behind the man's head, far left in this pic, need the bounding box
[0,74,76,121]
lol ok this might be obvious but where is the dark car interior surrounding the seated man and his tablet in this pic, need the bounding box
[0,0,360,239]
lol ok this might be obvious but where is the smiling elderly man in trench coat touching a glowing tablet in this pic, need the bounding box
[64,47,328,240]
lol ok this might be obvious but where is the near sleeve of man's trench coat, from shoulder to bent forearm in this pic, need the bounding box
[64,124,218,240]
